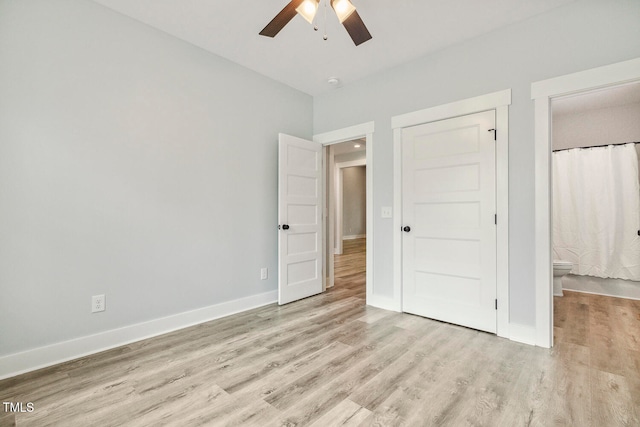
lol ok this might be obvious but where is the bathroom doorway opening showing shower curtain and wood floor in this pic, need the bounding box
[550,82,640,348]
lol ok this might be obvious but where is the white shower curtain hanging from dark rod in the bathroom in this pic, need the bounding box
[553,144,640,281]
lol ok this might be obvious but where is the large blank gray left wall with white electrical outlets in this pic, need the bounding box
[0,0,312,355]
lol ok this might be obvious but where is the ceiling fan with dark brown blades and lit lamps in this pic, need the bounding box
[260,0,372,46]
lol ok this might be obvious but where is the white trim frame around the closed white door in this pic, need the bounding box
[391,89,510,341]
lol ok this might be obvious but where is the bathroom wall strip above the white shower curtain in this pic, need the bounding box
[552,103,640,150]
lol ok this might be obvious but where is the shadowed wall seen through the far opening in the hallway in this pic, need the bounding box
[342,166,367,236]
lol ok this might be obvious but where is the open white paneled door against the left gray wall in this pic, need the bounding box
[278,134,323,304]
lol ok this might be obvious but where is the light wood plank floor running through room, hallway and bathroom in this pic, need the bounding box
[0,241,640,427]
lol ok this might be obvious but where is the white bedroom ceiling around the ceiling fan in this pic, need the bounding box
[94,0,575,95]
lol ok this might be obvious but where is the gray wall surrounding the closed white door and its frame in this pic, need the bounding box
[313,0,640,326]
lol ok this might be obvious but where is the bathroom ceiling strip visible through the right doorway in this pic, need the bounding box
[552,83,640,116]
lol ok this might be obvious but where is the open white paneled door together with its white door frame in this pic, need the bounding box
[278,122,374,305]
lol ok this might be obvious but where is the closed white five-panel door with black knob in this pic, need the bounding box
[402,111,497,333]
